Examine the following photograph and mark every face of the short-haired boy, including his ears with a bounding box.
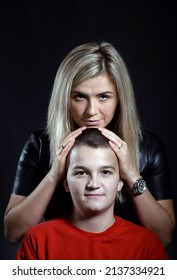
[65,145,122,218]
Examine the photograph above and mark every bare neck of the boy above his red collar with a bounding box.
[70,209,115,233]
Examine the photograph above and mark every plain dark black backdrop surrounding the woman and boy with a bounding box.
[0,0,177,259]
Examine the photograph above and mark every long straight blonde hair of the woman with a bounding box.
[47,42,142,169]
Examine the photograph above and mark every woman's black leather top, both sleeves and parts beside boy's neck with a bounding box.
[13,129,173,222]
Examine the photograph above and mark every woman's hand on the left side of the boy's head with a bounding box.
[49,127,86,183]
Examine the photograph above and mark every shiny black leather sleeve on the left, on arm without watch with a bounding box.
[12,130,49,196]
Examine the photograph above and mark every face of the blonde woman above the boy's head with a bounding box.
[71,73,118,127]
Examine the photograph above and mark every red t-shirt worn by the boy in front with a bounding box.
[16,217,168,260]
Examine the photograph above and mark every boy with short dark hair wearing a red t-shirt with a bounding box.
[17,128,167,260]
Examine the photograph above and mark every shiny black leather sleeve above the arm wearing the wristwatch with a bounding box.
[140,129,173,200]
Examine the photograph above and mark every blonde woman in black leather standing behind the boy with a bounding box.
[4,42,175,245]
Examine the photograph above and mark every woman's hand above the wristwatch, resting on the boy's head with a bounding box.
[98,127,141,187]
